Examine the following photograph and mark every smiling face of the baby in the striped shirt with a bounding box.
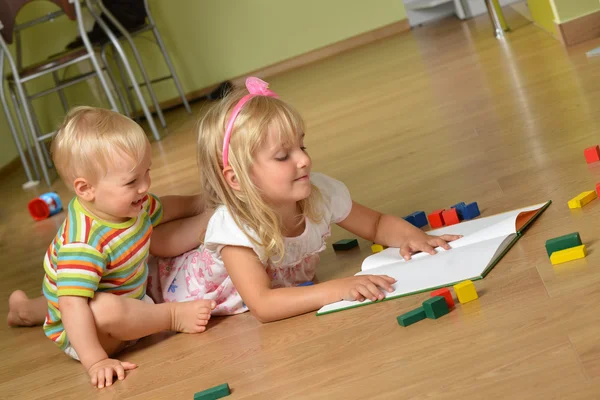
[86,144,152,222]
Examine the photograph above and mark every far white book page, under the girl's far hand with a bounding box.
[361,203,546,271]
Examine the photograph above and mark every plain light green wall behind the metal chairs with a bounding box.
[0,0,406,170]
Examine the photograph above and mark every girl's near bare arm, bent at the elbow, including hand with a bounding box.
[221,246,395,322]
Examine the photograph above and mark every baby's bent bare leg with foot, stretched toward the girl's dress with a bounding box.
[90,293,216,342]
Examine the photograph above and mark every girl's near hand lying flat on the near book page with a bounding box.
[331,275,396,301]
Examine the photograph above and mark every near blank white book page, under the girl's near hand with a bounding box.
[317,233,516,315]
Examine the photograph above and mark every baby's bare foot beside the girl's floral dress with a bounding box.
[169,300,217,333]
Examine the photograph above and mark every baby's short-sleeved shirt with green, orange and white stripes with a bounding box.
[43,195,162,350]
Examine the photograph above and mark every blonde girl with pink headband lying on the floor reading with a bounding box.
[149,78,458,322]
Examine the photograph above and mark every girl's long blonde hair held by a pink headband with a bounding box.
[198,86,322,260]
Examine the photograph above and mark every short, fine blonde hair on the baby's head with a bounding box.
[51,107,149,185]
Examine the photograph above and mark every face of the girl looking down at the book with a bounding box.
[252,129,312,206]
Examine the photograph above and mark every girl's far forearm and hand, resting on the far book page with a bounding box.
[338,201,461,260]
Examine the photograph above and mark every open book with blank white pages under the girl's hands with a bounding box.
[317,201,551,315]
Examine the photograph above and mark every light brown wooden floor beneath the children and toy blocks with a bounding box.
[0,9,600,400]
